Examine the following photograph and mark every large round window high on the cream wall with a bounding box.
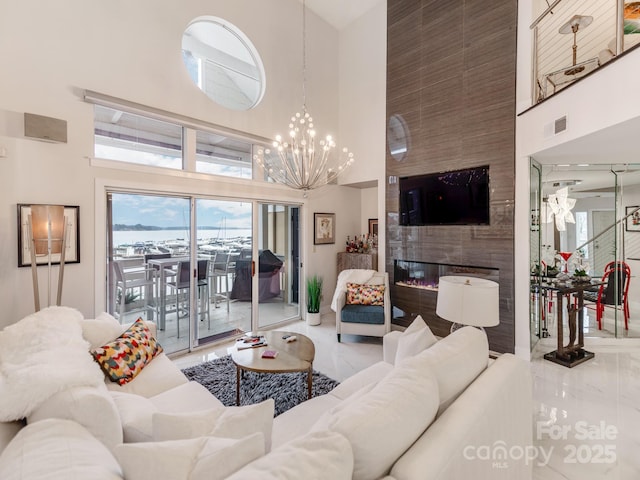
[182,17,265,110]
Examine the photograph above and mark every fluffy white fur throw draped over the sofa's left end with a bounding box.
[0,307,104,421]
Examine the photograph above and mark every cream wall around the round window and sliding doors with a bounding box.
[0,0,378,328]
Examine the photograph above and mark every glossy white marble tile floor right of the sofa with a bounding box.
[531,337,640,480]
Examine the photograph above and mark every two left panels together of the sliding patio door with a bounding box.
[107,192,253,353]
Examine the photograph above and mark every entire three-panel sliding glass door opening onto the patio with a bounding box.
[106,191,300,353]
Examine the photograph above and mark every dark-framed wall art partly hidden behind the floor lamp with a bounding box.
[18,203,80,267]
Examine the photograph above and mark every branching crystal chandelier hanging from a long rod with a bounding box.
[253,0,354,196]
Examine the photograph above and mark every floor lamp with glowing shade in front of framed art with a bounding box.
[28,205,67,312]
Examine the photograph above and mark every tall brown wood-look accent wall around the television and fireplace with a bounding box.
[386,0,517,352]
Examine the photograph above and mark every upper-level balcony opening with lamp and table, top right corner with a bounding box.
[531,0,640,103]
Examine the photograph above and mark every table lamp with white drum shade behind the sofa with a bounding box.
[436,276,500,332]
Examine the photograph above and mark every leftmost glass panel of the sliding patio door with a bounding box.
[107,192,191,352]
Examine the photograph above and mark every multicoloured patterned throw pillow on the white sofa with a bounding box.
[91,318,162,385]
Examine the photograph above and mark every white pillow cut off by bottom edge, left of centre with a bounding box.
[114,433,264,480]
